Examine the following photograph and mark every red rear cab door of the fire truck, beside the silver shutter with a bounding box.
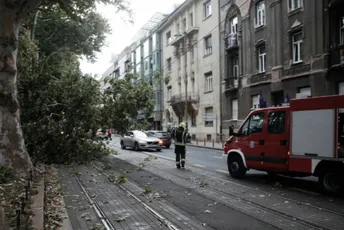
[264,110,289,171]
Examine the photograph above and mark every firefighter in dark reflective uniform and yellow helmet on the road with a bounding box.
[174,122,188,168]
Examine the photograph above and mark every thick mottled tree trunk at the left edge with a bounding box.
[0,4,32,174]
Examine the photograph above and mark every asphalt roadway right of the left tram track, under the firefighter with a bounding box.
[103,141,344,230]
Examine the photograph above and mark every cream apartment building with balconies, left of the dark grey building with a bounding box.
[159,0,221,140]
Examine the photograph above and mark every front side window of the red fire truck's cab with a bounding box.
[239,113,264,136]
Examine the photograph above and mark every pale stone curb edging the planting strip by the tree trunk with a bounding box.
[31,175,44,229]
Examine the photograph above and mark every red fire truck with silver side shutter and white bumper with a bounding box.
[223,95,344,195]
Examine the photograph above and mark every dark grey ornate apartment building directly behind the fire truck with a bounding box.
[221,0,344,137]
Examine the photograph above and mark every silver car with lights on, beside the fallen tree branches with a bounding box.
[120,130,163,151]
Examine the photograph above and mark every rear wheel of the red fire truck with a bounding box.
[319,172,342,196]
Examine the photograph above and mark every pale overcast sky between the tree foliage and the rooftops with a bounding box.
[80,0,184,75]
